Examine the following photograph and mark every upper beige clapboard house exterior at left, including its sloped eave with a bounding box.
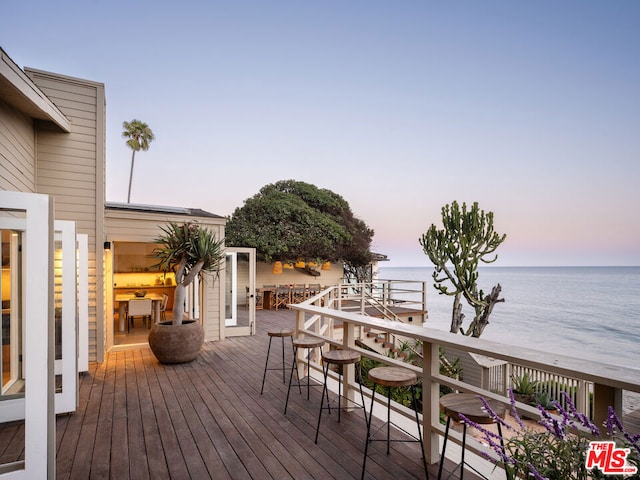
[0,55,105,361]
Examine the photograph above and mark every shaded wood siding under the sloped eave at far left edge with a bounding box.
[0,100,36,192]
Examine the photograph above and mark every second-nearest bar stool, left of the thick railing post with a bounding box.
[362,367,429,480]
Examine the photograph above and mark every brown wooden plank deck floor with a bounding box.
[0,310,477,480]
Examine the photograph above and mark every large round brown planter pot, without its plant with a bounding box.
[149,320,204,363]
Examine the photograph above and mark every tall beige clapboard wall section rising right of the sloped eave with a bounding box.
[25,69,106,362]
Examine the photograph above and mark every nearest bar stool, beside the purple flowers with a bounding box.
[438,393,509,480]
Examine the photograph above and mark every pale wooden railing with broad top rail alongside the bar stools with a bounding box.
[290,286,640,463]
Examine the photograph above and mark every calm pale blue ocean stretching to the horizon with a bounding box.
[379,267,640,369]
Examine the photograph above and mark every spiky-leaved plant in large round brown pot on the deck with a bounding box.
[149,222,224,363]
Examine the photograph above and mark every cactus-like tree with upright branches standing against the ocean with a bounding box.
[420,201,506,337]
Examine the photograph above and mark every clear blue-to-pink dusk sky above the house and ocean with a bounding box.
[0,0,640,266]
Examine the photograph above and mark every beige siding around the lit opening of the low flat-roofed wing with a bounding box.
[105,208,226,341]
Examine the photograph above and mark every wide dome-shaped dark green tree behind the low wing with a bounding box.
[225,180,373,274]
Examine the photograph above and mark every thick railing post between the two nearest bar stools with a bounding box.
[422,341,440,463]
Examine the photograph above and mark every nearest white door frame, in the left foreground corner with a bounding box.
[0,191,56,480]
